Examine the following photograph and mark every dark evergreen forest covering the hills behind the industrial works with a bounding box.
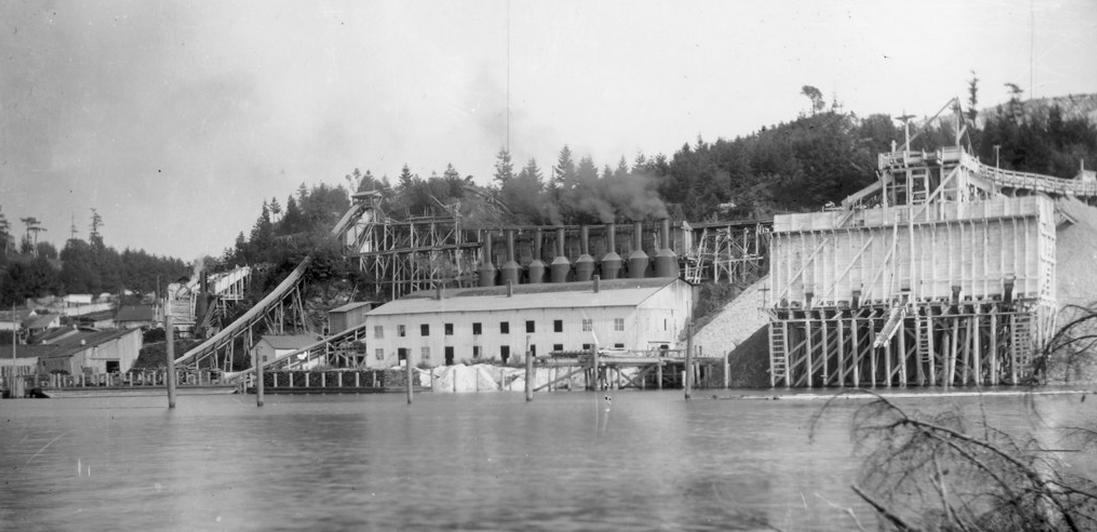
[0,81,1097,302]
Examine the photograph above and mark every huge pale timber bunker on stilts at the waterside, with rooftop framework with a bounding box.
[766,101,1097,387]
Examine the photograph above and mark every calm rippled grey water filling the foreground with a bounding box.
[0,392,1097,531]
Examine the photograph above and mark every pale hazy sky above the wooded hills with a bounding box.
[0,0,1097,261]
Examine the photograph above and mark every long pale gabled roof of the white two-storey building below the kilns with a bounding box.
[367,278,683,316]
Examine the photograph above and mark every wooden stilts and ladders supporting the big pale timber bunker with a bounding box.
[769,302,1037,388]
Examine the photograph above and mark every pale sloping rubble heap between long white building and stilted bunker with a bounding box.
[680,276,772,356]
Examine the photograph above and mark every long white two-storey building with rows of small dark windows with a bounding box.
[365,278,693,367]
